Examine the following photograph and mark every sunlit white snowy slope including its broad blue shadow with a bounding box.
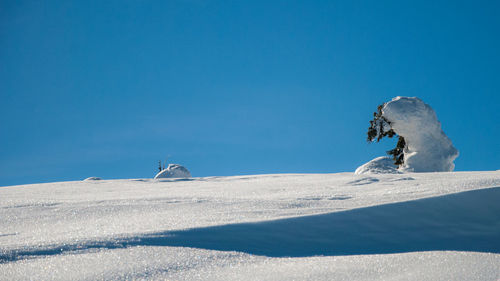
[0,171,500,280]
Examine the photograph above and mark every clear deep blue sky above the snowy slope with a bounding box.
[0,0,500,185]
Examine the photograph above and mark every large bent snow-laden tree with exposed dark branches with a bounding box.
[367,97,458,172]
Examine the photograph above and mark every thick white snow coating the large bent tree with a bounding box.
[382,97,458,172]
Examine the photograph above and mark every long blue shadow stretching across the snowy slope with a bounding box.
[0,187,500,262]
